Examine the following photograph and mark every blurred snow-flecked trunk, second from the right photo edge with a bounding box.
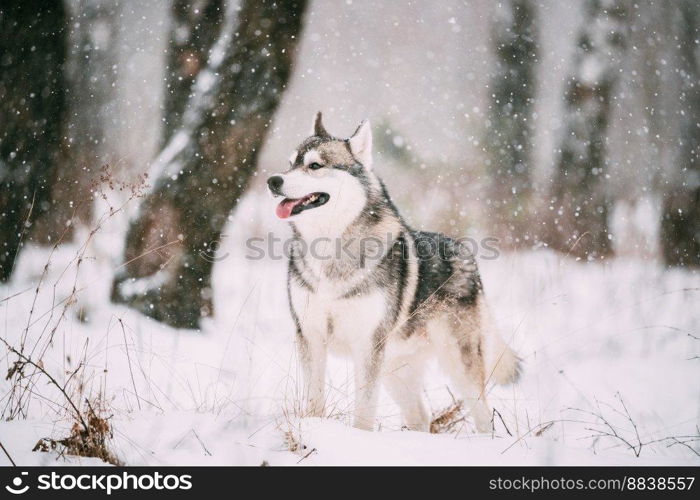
[546,0,630,260]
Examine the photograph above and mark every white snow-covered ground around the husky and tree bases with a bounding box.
[0,196,700,465]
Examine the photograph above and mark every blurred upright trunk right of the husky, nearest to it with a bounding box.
[487,0,537,246]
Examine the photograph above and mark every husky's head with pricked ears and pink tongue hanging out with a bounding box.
[267,112,377,229]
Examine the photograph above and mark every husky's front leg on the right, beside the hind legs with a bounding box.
[353,332,385,431]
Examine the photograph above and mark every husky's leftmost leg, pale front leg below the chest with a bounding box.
[297,333,327,417]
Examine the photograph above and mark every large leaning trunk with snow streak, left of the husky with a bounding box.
[112,0,306,328]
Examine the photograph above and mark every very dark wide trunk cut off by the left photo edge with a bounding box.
[0,0,67,281]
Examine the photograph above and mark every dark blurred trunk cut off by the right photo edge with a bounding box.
[661,0,700,267]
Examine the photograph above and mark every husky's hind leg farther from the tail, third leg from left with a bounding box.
[383,356,430,432]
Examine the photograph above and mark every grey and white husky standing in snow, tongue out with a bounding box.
[267,112,520,432]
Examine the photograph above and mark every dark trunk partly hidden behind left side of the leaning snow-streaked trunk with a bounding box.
[163,0,225,144]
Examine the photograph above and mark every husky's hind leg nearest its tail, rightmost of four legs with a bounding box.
[428,308,491,432]
